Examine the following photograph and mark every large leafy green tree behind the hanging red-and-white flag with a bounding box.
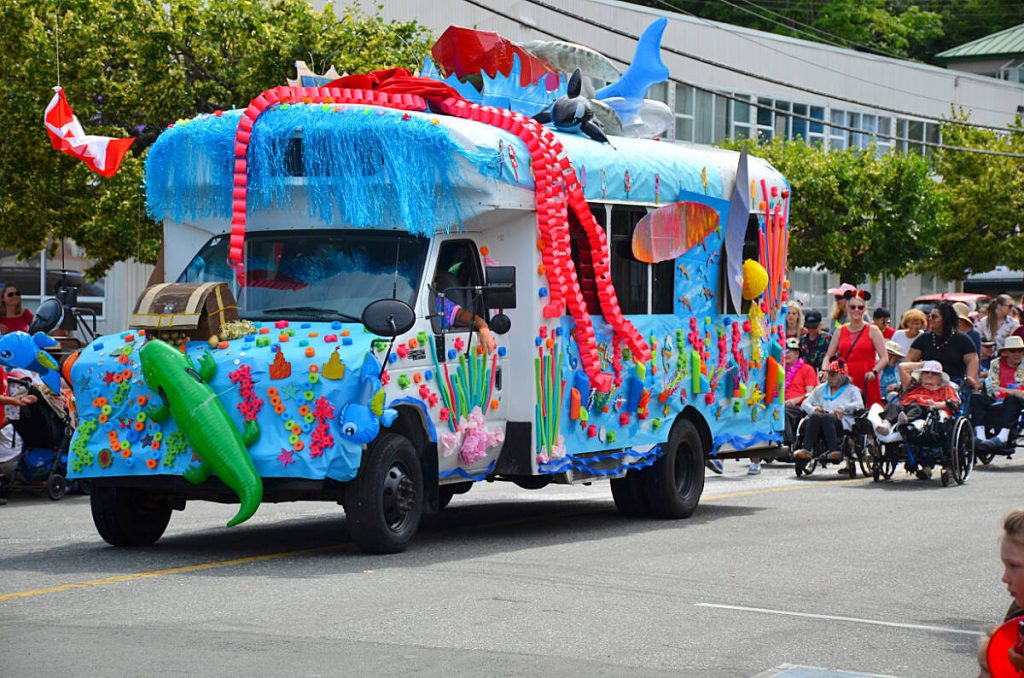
[0,0,431,277]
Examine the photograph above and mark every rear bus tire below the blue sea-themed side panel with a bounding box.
[641,419,705,518]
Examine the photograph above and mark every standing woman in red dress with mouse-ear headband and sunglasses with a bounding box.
[821,290,889,408]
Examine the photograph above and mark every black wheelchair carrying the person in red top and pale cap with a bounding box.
[867,391,975,486]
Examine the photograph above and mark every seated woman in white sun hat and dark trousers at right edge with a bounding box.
[971,335,1024,447]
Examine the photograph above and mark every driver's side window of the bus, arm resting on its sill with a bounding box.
[430,240,486,333]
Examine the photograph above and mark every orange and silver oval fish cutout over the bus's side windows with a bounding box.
[633,202,719,263]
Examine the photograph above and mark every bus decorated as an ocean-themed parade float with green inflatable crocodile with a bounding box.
[61,20,788,552]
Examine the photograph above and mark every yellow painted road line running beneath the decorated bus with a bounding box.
[0,478,867,602]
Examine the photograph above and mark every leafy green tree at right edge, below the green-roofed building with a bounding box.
[928,113,1024,280]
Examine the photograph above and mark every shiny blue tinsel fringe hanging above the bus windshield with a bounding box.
[146,105,483,236]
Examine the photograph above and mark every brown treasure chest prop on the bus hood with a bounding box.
[130,283,239,344]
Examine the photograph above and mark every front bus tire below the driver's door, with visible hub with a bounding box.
[345,433,421,553]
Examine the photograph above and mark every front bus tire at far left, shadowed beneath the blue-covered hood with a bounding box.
[89,485,171,546]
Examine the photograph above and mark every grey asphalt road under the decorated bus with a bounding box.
[0,460,1024,677]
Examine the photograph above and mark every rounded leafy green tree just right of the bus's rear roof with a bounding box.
[730,139,945,282]
